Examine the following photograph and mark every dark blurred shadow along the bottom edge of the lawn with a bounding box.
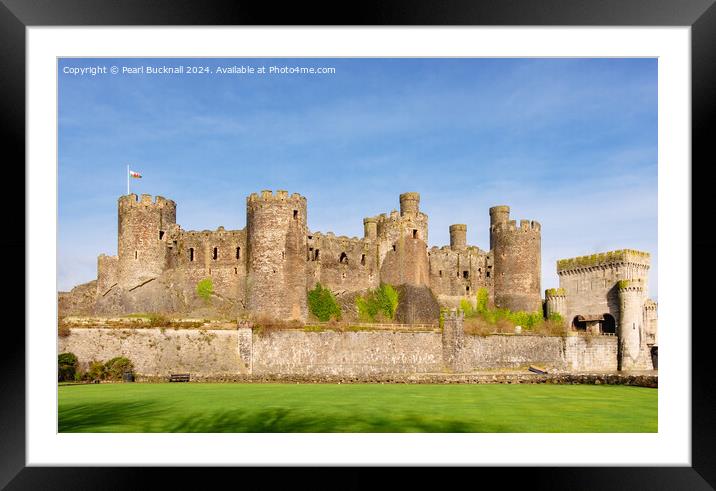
[59,401,498,433]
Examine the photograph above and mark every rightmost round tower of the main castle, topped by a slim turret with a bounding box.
[490,206,542,312]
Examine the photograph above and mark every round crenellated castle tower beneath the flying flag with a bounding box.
[117,194,176,288]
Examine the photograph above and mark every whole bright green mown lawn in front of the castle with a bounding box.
[58,383,657,433]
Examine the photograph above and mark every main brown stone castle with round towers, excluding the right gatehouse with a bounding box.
[81,191,542,320]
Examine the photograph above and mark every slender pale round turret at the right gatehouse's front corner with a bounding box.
[617,280,651,370]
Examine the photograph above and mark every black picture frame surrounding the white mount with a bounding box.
[0,0,716,490]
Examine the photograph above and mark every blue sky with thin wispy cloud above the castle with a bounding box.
[58,58,658,298]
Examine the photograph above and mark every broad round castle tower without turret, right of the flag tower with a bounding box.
[246,191,307,320]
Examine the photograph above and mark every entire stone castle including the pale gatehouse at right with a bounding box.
[60,191,656,369]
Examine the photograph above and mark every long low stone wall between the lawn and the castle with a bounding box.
[58,328,617,378]
